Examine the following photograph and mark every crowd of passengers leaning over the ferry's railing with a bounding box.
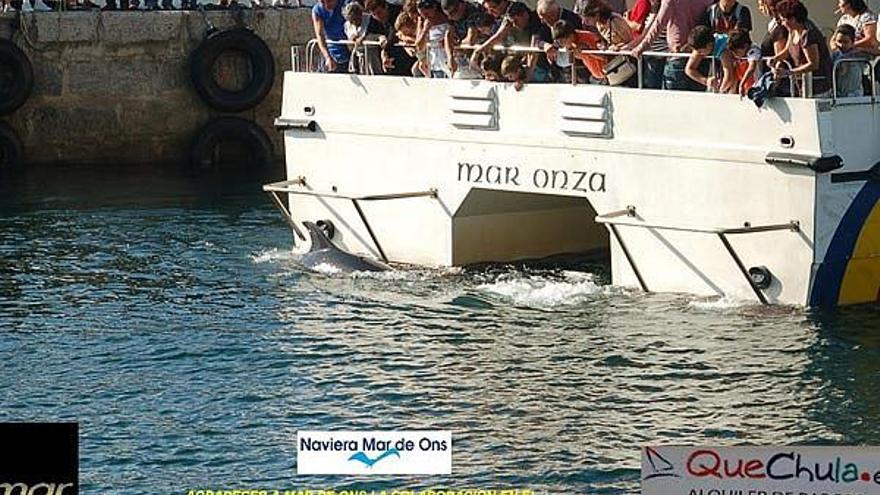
[312,0,880,96]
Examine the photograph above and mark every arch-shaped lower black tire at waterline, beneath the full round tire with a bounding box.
[190,117,274,171]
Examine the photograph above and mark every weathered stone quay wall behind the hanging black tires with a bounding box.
[0,9,312,164]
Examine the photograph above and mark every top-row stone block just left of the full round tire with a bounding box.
[101,11,183,45]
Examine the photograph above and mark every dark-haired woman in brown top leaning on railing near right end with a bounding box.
[770,0,833,96]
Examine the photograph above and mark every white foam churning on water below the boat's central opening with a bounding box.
[477,271,604,308]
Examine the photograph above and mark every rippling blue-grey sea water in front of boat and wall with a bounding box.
[0,167,880,494]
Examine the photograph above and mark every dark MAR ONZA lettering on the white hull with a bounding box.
[458,162,605,193]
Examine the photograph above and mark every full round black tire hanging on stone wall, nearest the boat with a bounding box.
[190,28,275,112]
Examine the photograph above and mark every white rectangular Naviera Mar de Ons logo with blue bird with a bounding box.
[296,430,452,474]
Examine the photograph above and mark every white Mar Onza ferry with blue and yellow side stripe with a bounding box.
[265,43,880,306]
